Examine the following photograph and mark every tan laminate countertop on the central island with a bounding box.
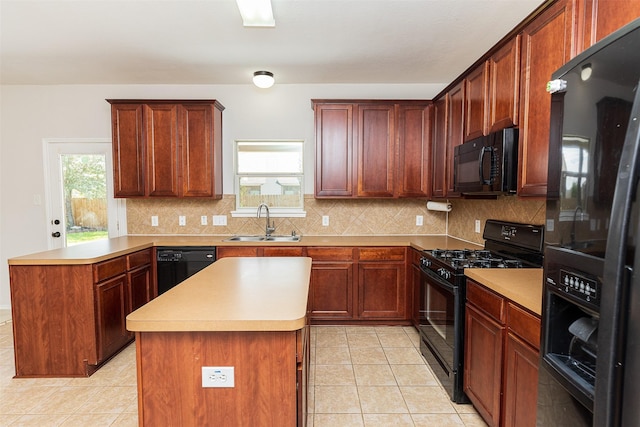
[127,257,311,332]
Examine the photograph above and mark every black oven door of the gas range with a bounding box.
[419,267,467,403]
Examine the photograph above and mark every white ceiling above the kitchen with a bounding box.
[0,0,543,85]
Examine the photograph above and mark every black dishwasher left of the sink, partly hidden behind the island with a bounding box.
[156,246,216,295]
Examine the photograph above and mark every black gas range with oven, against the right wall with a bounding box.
[419,220,544,403]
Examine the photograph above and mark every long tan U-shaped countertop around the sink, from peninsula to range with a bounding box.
[9,235,482,265]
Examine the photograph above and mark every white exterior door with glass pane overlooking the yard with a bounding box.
[44,139,127,249]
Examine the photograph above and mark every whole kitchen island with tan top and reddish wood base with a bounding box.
[127,257,311,426]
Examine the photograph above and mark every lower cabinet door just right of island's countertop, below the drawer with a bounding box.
[309,262,354,320]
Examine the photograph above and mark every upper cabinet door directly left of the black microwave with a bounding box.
[445,81,466,197]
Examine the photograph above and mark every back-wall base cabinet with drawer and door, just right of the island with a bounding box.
[307,247,355,320]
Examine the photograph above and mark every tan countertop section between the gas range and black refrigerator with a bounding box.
[464,268,543,316]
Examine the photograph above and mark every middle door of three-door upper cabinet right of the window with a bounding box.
[357,103,396,197]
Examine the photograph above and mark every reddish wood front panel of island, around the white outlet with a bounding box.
[136,331,297,427]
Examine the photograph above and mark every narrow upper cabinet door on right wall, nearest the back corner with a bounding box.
[431,95,448,197]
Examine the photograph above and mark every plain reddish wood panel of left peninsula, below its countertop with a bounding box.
[9,265,96,377]
